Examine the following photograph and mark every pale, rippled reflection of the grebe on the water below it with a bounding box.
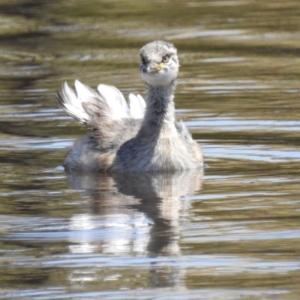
[67,169,203,286]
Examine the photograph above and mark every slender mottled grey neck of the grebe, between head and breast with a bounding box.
[140,80,176,134]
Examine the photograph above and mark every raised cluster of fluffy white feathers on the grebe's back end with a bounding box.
[58,80,146,123]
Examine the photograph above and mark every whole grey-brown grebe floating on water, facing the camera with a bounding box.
[57,41,203,172]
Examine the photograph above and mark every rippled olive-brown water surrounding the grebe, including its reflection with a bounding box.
[0,0,300,300]
